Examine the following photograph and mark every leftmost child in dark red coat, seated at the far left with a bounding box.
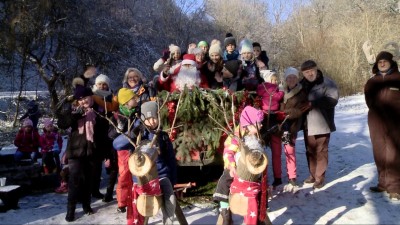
[14,119,40,162]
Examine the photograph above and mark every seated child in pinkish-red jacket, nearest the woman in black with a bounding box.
[40,118,63,174]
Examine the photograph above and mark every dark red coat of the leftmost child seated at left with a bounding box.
[14,128,40,152]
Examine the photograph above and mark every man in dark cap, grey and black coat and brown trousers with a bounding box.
[300,60,339,188]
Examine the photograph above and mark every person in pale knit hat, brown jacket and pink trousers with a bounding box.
[281,67,308,186]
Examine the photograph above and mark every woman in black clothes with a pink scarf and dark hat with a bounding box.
[60,85,107,222]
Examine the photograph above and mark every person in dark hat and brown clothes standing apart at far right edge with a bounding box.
[364,51,400,200]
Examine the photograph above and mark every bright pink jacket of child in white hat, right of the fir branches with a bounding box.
[257,82,285,113]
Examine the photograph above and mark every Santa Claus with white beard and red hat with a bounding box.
[159,54,208,92]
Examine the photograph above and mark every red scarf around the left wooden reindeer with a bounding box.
[126,178,162,225]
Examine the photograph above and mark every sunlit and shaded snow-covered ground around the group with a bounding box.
[0,95,400,224]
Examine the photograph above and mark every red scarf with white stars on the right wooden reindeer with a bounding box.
[230,176,265,225]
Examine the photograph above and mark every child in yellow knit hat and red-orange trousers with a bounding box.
[109,88,138,213]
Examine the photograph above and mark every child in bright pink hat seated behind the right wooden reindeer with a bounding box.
[213,106,264,224]
